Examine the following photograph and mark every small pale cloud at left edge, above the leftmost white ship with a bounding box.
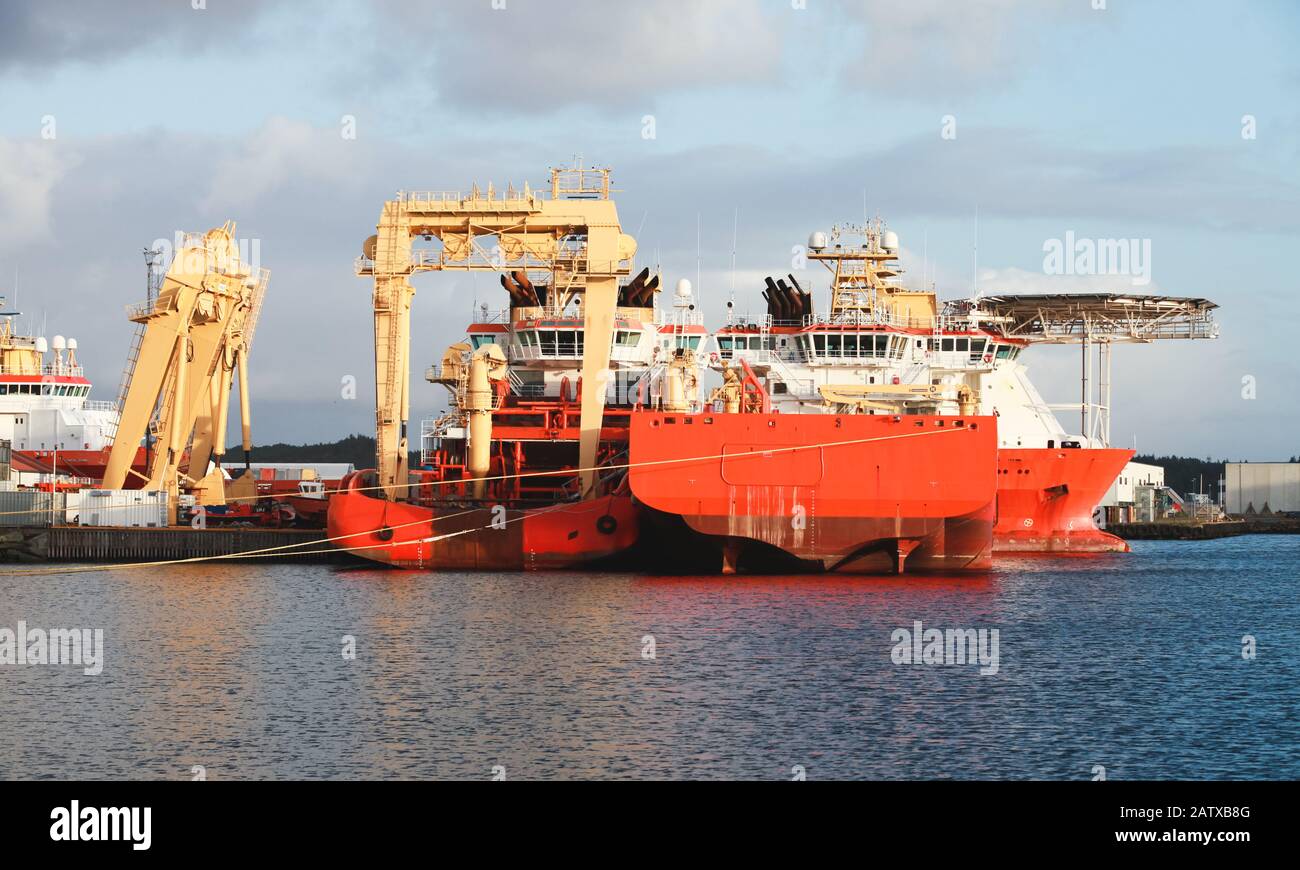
[0,138,81,247]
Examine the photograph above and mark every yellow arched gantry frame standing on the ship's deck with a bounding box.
[356,169,636,501]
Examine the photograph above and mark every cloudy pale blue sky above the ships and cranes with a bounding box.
[0,0,1300,459]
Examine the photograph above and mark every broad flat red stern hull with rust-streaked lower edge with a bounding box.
[629,414,997,573]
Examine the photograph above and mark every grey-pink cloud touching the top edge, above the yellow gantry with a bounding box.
[376,0,783,114]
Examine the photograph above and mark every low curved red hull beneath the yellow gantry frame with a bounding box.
[328,475,638,571]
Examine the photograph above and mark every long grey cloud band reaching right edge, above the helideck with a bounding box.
[619,127,1300,239]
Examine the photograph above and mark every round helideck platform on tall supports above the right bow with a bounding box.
[944,293,1218,446]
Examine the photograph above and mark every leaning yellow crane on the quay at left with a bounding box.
[104,221,269,521]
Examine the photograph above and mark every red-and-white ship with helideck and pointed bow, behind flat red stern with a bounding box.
[710,221,1216,553]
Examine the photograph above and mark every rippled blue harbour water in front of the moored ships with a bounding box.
[0,537,1300,779]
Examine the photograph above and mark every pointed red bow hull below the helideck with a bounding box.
[993,447,1134,553]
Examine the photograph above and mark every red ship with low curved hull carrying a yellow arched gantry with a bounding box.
[328,169,670,570]
